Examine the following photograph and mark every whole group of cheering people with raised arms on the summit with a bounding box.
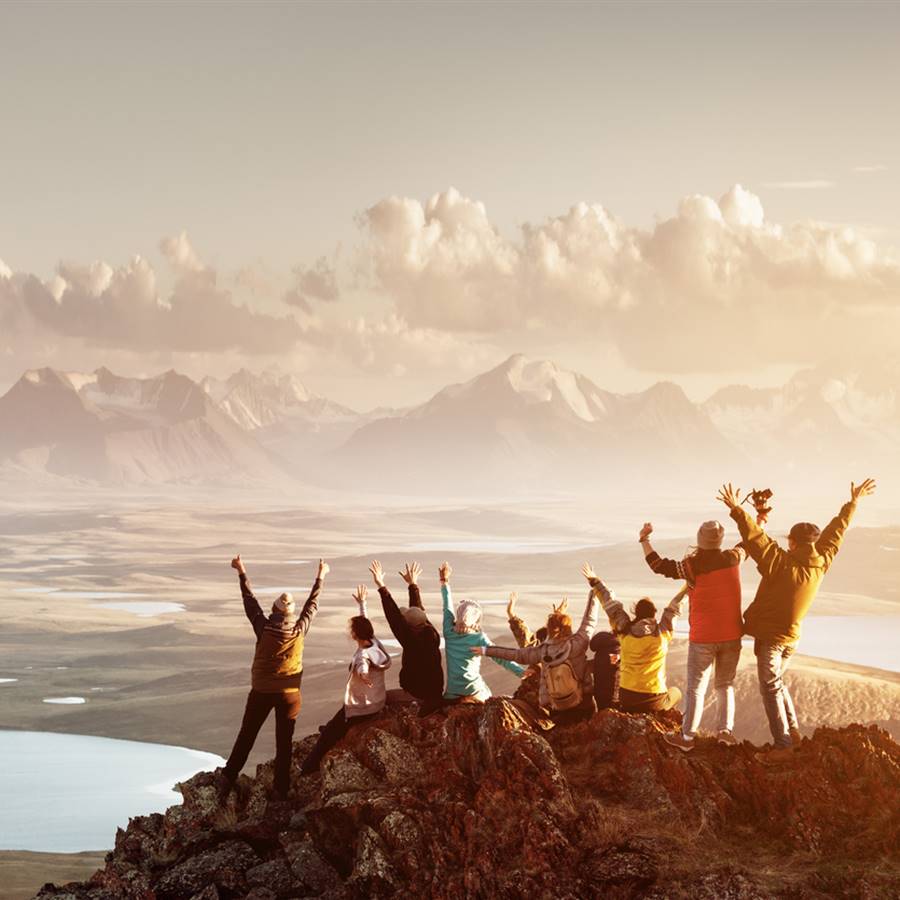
[220,479,875,799]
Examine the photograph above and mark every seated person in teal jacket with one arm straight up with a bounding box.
[438,562,526,703]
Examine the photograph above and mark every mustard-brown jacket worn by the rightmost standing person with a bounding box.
[731,500,856,645]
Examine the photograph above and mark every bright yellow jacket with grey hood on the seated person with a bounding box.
[591,579,685,694]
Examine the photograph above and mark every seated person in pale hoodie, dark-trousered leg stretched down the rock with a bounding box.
[300,584,391,775]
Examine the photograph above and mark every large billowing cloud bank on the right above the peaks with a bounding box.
[360,185,900,372]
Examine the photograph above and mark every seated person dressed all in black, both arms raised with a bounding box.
[369,560,444,717]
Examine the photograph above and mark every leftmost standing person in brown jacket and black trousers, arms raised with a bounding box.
[219,554,328,801]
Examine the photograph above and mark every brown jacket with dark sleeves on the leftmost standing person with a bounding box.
[240,573,322,694]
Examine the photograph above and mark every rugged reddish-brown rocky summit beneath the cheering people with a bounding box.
[38,698,900,900]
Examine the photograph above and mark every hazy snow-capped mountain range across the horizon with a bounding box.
[0,354,900,492]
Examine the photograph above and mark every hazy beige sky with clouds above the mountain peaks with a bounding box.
[0,2,900,409]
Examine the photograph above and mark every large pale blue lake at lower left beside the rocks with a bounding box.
[0,730,224,853]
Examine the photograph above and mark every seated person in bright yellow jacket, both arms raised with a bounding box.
[581,563,687,712]
